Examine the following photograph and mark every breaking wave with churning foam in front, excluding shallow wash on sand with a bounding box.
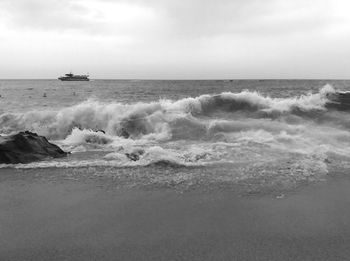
[0,85,350,165]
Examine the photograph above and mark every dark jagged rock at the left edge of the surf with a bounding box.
[0,131,67,164]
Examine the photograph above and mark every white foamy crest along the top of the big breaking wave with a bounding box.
[0,85,334,140]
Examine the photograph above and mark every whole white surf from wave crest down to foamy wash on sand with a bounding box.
[0,85,350,191]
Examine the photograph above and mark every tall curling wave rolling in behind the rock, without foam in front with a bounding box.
[0,85,350,142]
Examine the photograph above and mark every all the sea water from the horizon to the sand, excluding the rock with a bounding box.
[0,80,350,191]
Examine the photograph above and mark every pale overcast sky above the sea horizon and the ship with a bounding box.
[0,0,350,79]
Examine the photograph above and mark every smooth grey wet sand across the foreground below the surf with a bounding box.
[0,169,350,261]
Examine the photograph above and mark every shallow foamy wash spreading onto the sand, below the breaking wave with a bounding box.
[0,143,330,192]
